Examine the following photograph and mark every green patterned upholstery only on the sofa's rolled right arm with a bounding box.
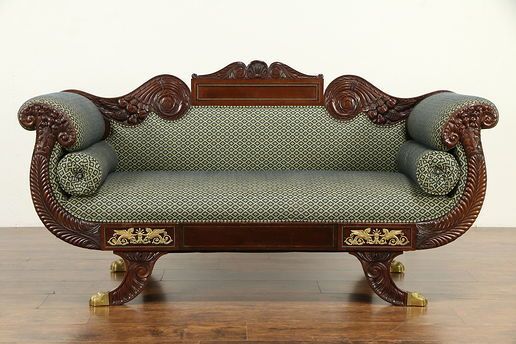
[407,92,496,150]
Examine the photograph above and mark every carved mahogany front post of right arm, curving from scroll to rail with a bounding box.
[417,104,498,249]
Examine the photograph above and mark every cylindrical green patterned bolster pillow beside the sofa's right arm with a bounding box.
[397,141,460,195]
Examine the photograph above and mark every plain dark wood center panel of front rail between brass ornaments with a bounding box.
[181,224,336,251]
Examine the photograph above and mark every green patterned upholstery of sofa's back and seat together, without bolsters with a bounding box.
[33,106,472,223]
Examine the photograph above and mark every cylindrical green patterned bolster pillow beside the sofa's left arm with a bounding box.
[57,141,118,196]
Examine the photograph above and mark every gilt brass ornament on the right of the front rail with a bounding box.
[344,228,409,246]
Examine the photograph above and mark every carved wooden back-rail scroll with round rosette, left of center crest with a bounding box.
[66,75,190,125]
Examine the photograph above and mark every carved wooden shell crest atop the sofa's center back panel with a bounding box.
[192,60,322,79]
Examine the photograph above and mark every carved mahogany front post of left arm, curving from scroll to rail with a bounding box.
[18,103,100,249]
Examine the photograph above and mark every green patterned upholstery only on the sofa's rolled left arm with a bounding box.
[19,92,105,151]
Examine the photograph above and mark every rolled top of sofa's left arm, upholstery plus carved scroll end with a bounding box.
[18,92,106,151]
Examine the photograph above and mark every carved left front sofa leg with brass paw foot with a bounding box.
[90,252,165,307]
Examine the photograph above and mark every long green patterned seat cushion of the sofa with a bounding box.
[62,171,456,222]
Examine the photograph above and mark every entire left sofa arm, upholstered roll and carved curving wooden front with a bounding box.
[18,92,106,249]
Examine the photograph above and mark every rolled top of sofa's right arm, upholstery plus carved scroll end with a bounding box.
[407,92,498,151]
